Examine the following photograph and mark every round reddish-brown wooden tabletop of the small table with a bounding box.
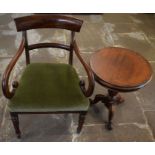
[90,47,152,90]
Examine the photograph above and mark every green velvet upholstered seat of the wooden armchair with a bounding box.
[9,63,89,112]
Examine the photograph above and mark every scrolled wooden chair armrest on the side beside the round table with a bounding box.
[73,40,95,97]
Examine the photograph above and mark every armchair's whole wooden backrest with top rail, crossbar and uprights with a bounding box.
[15,15,83,65]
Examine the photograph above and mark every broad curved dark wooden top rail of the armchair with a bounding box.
[14,14,83,32]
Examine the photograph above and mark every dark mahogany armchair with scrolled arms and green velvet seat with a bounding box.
[2,15,94,138]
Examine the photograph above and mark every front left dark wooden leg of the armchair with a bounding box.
[10,112,21,138]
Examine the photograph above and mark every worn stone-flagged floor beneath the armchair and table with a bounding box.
[0,14,155,142]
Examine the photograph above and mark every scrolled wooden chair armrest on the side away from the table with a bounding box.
[2,38,25,99]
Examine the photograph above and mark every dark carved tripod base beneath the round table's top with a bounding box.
[91,90,124,130]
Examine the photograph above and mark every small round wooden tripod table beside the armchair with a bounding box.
[90,47,152,130]
